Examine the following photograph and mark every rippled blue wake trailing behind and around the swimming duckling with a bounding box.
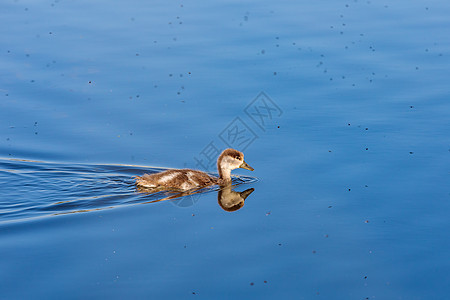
[0,159,256,222]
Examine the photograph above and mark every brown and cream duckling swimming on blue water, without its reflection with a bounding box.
[136,148,254,191]
